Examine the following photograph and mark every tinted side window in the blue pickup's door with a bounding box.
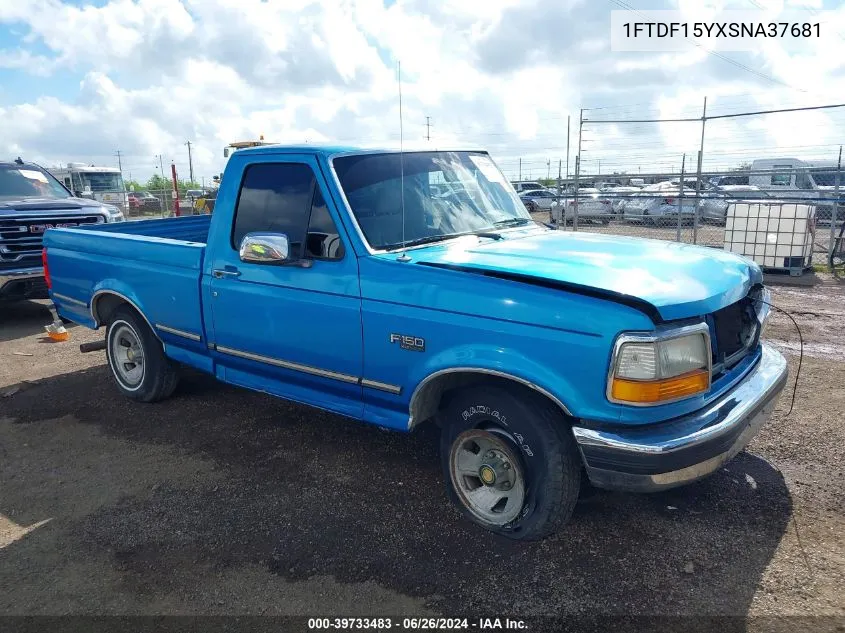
[232,163,315,257]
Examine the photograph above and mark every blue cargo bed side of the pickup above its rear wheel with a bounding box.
[44,215,211,338]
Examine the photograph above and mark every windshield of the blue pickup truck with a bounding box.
[333,152,531,249]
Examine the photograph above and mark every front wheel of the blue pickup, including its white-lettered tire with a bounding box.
[439,383,581,541]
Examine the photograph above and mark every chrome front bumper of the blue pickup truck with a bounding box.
[572,343,788,492]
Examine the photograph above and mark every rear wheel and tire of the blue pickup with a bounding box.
[106,305,179,402]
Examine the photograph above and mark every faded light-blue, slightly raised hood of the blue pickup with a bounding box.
[400,229,762,321]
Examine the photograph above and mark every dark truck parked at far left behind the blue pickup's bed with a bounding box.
[0,158,124,301]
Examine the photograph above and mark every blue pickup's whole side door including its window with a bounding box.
[204,155,363,417]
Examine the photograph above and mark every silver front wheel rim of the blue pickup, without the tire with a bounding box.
[449,429,525,526]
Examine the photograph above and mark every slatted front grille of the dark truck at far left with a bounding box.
[0,213,105,270]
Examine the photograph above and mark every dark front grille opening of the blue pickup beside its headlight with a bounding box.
[707,290,760,375]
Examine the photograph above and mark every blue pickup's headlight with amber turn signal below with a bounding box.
[607,323,711,405]
